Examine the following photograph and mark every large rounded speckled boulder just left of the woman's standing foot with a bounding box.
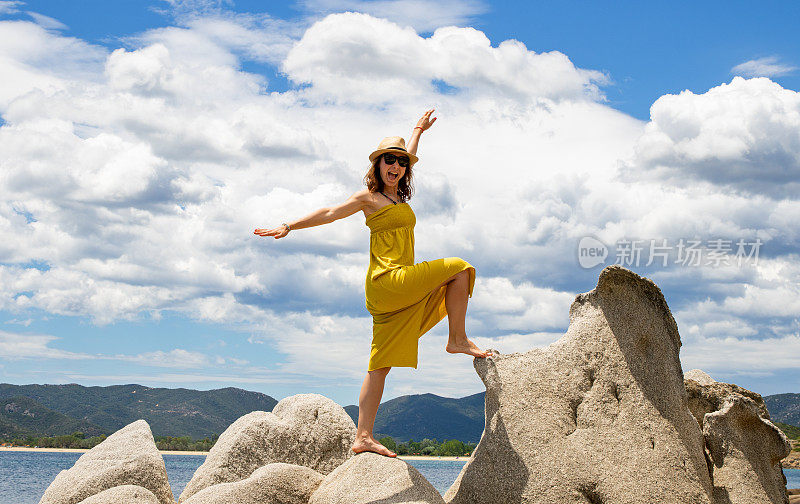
[183,394,356,502]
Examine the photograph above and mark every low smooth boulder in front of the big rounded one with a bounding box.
[185,462,324,504]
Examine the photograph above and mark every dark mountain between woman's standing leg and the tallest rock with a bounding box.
[344,392,485,443]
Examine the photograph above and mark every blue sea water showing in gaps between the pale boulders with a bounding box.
[0,451,800,504]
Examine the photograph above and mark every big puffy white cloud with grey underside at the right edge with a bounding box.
[622,77,800,199]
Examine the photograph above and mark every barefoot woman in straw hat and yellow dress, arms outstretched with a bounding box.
[255,109,491,457]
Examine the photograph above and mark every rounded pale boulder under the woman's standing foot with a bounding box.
[308,452,444,504]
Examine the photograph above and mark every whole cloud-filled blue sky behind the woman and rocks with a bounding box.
[0,0,800,405]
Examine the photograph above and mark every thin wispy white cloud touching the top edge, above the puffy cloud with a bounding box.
[300,0,488,32]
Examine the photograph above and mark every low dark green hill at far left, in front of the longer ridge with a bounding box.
[0,396,111,438]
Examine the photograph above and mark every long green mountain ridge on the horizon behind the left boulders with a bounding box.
[0,383,278,439]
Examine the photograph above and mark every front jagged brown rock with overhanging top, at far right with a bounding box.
[703,394,790,504]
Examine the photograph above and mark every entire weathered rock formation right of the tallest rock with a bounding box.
[684,369,790,504]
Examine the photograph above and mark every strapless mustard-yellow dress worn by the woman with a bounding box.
[364,203,475,371]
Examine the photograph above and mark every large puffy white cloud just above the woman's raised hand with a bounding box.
[283,13,607,104]
